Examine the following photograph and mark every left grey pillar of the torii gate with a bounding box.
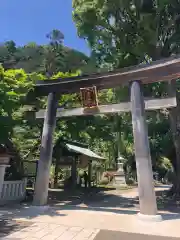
[33,93,58,206]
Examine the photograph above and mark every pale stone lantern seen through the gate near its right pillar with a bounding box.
[114,156,126,187]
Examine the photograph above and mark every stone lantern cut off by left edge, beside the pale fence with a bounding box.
[0,144,11,195]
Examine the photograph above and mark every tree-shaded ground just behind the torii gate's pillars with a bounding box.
[46,187,180,214]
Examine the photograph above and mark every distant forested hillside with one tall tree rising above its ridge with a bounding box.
[0,30,95,74]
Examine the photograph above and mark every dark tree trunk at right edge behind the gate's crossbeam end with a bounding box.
[168,80,180,195]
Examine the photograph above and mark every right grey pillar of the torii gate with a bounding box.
[131,81,158,217]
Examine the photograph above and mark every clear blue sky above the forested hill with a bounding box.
[0,0,89,54]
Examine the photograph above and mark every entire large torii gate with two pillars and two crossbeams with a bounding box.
[29,56,180,219]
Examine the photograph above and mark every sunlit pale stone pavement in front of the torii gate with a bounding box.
[2,186,180,240]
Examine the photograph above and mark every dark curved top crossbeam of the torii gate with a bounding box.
[35,55,180,96]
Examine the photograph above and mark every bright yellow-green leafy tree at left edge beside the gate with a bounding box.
[0,66,35,178]
